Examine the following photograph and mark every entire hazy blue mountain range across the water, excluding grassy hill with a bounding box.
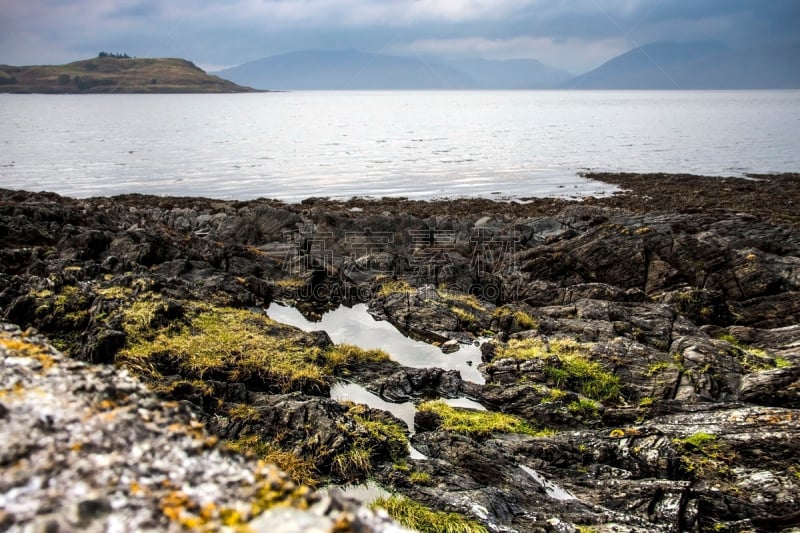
[218,41,800,90]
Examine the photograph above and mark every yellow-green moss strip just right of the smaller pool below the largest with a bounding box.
[418,400,543,437]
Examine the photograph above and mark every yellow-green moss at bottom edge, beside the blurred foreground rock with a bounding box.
[371,496,488,533]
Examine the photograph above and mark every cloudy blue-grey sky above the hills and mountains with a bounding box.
[0,0,800,73]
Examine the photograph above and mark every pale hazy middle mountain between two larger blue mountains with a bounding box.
[447,58,573,89]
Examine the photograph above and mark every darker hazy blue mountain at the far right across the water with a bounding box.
[559,42,800,89]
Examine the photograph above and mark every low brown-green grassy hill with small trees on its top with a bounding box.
[0,57,254,94]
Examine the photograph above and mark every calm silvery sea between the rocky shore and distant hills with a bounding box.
[0,91,800,201]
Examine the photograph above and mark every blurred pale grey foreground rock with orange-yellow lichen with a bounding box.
[0,323,403,533]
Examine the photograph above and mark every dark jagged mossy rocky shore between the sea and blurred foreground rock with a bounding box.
[0,174,800,532]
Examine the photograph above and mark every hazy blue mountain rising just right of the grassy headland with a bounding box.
[217,50,474,90]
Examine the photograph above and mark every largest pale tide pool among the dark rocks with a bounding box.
[266,302,486,384]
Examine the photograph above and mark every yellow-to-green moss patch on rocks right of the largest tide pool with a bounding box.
[498,339,622,401]
